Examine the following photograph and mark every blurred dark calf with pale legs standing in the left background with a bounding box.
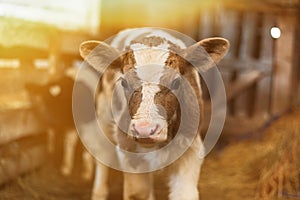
[26,75,94,179]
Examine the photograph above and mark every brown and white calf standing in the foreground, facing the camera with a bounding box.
[80,28,229,200]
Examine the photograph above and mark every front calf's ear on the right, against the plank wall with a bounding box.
[184,37,230,71]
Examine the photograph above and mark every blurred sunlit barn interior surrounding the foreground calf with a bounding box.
[0,0,300,200]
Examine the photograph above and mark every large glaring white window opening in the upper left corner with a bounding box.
[0,0,101,34]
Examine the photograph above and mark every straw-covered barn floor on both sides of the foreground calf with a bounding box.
[0,108,300,200]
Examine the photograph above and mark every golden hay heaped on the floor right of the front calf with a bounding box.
[200,108,300,200]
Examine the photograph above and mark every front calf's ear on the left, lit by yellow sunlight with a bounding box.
[79,40,121,73]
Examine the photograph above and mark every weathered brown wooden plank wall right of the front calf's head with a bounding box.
[198,0,300,133]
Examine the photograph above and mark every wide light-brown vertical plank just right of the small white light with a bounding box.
[271,15,297,115]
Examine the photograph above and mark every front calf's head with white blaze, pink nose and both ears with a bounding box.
[80,36,229,144]
